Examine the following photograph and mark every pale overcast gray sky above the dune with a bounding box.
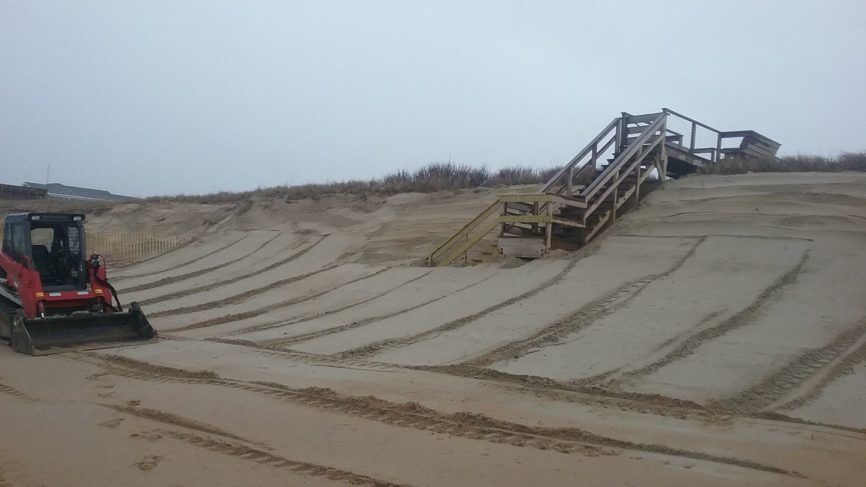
[0,0,866,196]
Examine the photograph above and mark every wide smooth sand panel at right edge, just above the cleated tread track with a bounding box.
[626,243,866,404]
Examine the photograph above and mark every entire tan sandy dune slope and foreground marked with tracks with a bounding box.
[0,174,866,486]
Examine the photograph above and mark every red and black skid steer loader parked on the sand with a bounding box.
[0,213,156,355]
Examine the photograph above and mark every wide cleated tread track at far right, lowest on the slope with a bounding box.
[708,320,866,414]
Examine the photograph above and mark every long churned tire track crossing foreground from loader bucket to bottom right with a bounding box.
[78,353,803,478]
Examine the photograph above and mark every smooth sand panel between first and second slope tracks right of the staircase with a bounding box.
[496,237,808,381]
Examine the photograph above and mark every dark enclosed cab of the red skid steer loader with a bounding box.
[3,213,87,291]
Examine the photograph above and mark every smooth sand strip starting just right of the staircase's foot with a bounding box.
[371,237,700,365]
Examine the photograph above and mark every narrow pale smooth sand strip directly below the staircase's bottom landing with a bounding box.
[291,260,569,354]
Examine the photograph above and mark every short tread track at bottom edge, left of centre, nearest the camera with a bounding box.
[158,430,401,487]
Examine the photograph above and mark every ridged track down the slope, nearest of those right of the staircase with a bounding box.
[464,237,707,367]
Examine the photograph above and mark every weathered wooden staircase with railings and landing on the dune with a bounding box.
[427,108,779,266]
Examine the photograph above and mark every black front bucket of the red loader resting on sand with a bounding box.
[10,303,156,355]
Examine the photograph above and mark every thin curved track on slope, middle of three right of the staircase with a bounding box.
[617,250,810,388]
